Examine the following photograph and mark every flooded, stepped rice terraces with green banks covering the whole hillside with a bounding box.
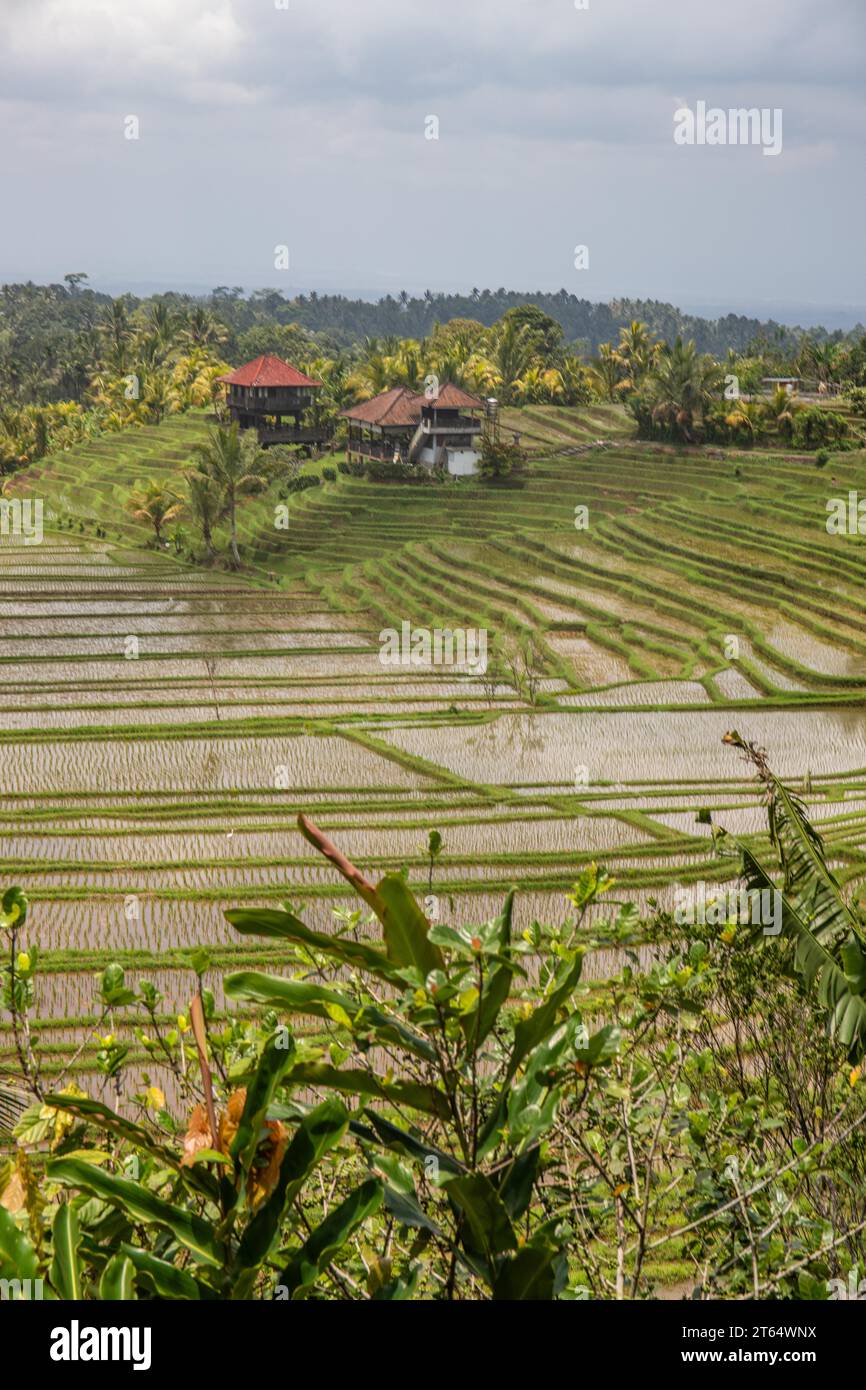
[0,406,866,1056]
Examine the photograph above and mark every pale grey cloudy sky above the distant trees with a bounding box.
[0,0,866,318]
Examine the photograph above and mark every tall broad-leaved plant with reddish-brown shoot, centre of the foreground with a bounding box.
[225,815,616,1300]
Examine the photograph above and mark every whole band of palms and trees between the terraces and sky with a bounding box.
[0,275,866,473]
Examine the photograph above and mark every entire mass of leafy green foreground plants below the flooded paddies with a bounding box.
[0,734,866,1300]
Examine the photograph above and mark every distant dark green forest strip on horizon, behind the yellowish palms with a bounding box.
[0,274,866,403]
